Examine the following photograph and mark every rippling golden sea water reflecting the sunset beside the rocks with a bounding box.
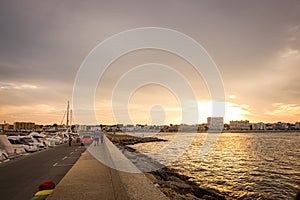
[133,133,300,199]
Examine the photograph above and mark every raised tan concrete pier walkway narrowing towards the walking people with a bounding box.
[47,138,168,200]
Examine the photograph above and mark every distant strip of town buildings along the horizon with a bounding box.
[0,117,300,133]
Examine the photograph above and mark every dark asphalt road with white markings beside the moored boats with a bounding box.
[0,144,86,200]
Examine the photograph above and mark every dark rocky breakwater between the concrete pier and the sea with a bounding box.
[108,135,225,200]
